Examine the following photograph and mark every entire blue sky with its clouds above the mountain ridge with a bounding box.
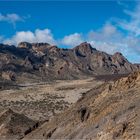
[0,0,140,62]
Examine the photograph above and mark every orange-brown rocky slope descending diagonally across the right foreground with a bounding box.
[24,72,140,140]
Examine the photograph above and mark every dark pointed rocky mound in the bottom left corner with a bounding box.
[0,109,38,139]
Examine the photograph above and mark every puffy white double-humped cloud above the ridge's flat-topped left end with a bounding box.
[3,29,56,45]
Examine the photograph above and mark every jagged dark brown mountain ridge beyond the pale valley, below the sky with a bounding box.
[0,42,139,83]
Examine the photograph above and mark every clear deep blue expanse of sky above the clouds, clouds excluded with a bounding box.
[0,1,125,38]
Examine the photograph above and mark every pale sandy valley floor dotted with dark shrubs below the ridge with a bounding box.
[0,78,102,120]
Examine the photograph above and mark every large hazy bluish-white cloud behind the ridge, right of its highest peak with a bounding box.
[86,23,140,62]
